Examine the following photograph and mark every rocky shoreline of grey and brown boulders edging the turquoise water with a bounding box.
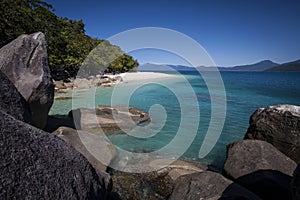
[0,33,300,200]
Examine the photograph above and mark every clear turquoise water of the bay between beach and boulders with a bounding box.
[50,72,300,167]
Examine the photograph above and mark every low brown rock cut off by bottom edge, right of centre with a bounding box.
[169,171,260,200]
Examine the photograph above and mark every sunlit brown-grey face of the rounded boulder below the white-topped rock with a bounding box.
[224,140,296,179]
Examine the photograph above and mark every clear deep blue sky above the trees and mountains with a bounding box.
[46,0,300,66]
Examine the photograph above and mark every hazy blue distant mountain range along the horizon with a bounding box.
[138,60,300,72]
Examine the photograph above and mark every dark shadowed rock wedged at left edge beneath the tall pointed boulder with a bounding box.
[0,71,31,123]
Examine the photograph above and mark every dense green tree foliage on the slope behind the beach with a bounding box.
[0,0,138,79]
